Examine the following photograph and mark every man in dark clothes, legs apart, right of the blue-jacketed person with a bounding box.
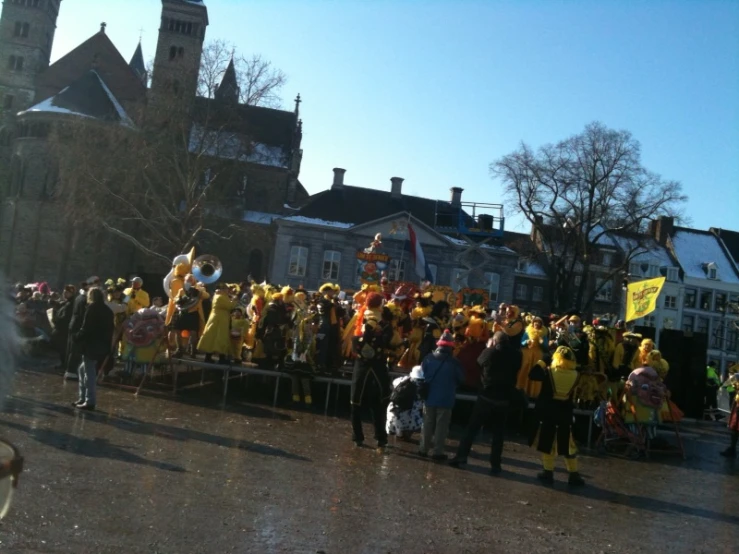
[449,331,522,474]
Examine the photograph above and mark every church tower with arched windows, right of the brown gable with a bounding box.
[151,0,208,104]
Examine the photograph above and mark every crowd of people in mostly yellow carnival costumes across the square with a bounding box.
[15,252,739,476]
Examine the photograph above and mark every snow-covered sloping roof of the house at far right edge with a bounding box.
[672,228,739,284]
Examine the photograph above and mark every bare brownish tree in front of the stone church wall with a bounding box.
[49,100,251,265]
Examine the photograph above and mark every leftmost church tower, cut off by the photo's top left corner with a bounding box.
[0,0,61,118]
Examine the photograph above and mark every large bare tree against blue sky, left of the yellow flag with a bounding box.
[490,122,687,311]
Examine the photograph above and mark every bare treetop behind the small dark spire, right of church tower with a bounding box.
[198,40,287,108]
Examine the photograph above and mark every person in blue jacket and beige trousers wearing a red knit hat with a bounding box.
[418,329,464,460]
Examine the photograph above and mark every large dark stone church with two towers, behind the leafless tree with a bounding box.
[0,0,308,293]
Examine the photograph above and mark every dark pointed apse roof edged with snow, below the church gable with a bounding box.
[18,70,133,126]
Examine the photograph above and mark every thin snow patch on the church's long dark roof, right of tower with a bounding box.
[189,124,287,168]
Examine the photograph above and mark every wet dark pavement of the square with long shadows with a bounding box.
[0,360,739,553]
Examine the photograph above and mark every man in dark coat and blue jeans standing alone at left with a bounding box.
[73,287,115,411]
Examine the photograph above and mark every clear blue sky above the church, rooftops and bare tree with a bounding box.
[52,0,739,231]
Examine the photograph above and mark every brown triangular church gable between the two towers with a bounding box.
[36,31,146,103]
